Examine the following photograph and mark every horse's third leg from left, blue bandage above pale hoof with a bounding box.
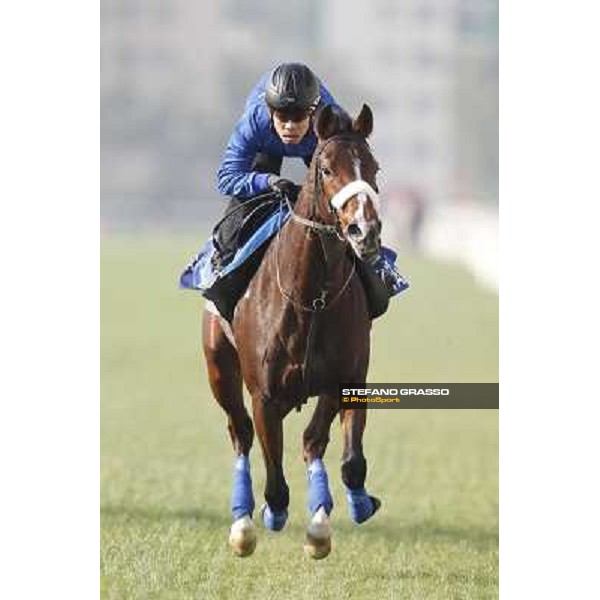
[303,394,339,558]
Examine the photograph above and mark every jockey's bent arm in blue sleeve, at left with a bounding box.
[217,111,269,198]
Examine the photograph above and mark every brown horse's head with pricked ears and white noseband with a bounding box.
[314,104,381,261]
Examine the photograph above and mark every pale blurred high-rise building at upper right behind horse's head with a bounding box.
[324,0,498,201]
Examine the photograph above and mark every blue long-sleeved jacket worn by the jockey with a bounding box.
[217,73,337,198]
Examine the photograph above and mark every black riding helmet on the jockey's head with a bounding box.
[265,63,321,110]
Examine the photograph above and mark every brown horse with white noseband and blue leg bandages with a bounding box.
[203,105,381,558]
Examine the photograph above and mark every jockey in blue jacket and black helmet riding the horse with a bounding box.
[214,63,408,296]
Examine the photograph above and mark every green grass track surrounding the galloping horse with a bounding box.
[101,234,498,599]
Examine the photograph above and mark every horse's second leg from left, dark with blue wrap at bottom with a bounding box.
[252,396,290,531]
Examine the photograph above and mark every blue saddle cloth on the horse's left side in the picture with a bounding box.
[179,202,290,321]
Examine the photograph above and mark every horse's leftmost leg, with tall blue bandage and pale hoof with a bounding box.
[202,311,256,556]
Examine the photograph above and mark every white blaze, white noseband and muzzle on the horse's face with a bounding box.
[331,151,381,261]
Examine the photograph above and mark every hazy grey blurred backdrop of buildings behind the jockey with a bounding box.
[101,0,498,253]
